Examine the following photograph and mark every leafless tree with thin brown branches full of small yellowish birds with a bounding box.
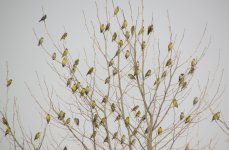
[1,0,225,150]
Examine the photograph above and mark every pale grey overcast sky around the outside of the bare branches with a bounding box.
[0,0,229,150]
